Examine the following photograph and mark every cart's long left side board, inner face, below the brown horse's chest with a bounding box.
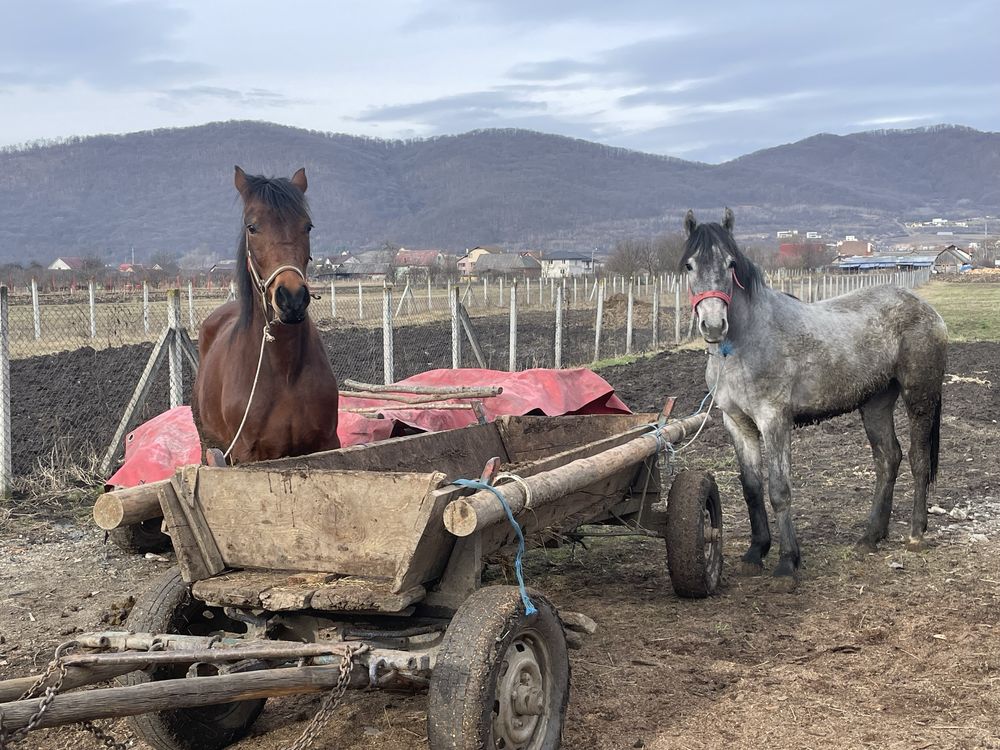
[244,422,509,480]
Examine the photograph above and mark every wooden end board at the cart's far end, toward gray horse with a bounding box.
[497,414,657,474]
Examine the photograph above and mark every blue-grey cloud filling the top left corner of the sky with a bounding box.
[0,0,208,89]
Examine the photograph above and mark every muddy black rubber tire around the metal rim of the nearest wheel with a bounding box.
[427,586,570,750]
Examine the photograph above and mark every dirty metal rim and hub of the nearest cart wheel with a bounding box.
[493,637,547,750]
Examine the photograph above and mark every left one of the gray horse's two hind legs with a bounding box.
[857,383,903,552]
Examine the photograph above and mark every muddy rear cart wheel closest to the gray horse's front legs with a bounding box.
[666,471,722,599]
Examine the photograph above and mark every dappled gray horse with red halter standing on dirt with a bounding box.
[681,208,948,589]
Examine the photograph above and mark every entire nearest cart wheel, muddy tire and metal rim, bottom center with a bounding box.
[427,586,569,750]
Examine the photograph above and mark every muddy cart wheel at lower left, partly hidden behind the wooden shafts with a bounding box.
[125,567,265,750]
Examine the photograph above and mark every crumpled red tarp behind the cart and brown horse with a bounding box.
[108,368,630,494]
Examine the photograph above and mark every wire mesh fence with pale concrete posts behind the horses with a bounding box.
[0,272,928,496]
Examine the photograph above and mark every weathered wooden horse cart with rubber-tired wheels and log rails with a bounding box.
[0,414,722,750]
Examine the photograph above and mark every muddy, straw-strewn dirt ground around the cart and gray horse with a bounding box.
[0,344,1000,750]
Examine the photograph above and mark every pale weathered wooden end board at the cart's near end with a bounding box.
[193,467,443,580]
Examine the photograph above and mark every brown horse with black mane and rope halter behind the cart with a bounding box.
[192,167,340,463]
